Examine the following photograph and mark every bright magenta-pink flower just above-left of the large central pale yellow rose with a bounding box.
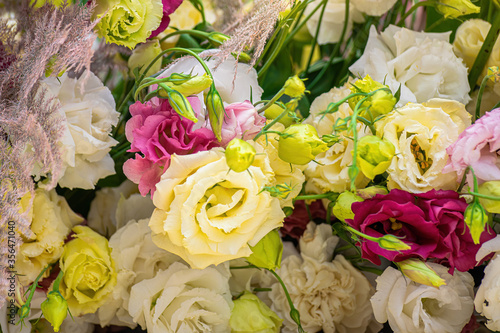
[123,97,218,196]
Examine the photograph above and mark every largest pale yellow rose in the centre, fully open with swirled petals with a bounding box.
[149,149,284,269]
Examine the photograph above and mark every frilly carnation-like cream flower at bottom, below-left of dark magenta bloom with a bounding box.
[269,222,378,333]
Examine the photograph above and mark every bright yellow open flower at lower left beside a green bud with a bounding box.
[59,226,117,316]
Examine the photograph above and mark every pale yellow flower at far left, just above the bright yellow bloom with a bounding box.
[16,189,83,286]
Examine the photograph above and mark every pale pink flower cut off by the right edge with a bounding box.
[443,109,500,185]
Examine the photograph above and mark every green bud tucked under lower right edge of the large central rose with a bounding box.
[247,229,283,270]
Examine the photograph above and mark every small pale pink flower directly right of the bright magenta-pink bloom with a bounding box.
[221,101,266,147]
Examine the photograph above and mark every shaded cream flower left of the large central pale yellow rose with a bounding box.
[87,180,155,237]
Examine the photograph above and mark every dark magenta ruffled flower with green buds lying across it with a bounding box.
[346,189,495,272]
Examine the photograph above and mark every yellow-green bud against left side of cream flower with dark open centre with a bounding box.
[357,135,396,179]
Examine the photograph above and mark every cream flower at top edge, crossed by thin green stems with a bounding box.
[304,0,364,45]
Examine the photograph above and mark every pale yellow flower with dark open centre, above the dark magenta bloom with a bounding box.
[375,98,471,193]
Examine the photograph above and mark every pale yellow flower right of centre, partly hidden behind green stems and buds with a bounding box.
[304,83,371,193]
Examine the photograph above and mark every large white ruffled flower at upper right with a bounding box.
[349,25,470,105]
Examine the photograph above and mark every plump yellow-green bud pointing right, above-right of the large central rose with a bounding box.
[278,124,328,165]
